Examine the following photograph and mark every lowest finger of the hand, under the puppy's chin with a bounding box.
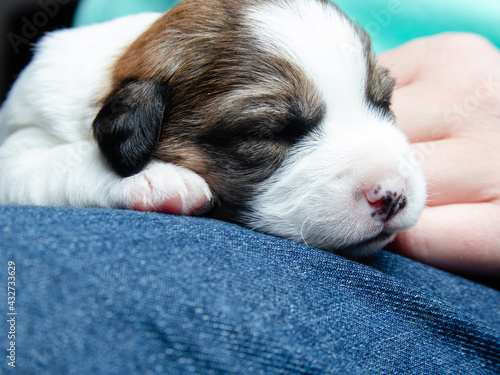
[393,203,500,277]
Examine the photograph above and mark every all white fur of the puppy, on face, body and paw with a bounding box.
[0,0,425,253]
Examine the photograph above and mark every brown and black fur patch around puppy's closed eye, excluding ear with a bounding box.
[106,0,324,219]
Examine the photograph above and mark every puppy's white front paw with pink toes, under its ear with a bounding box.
[120,161,212,215]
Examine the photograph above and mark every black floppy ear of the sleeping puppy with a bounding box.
[93,80,168,177]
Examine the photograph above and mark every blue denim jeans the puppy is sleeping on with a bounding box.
[0,207,500,375]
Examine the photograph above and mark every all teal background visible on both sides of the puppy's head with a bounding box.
[74,0,500,52]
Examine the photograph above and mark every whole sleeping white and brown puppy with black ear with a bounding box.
[0,0,425,256]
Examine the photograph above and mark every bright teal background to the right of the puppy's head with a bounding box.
[335,0,500,52]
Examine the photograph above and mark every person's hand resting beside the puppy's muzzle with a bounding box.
[379,34,500,277]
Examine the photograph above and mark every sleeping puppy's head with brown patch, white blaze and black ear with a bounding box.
[94,0,425,254]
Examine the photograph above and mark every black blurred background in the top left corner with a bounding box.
[0,0,78,103]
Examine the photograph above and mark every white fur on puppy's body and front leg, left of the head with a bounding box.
[0,13,211,214]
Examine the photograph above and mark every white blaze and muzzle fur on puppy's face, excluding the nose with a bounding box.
[247,0,426,255]
